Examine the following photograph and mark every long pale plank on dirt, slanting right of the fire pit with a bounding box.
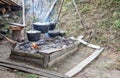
[65,48,104,77]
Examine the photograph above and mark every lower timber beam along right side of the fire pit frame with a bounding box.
[48,47,78,67]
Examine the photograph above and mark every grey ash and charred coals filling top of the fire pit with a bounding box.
[18,37,75,53]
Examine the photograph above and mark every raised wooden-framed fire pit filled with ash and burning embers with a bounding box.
[10,37,78,67]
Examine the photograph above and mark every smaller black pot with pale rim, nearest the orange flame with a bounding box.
[27,30,41,42]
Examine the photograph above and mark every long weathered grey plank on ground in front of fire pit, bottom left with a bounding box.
[0,60,69,78]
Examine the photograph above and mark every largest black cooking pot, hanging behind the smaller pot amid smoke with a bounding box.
[33,22,56,33]
